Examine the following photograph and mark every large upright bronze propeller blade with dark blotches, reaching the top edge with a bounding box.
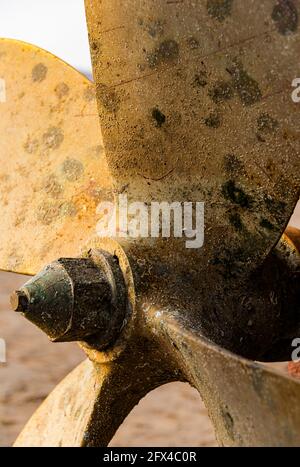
[85,0,300,280]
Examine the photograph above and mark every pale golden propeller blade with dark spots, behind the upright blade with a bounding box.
[0,39,113,274]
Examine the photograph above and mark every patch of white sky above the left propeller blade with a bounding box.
[0,0,92,77]
